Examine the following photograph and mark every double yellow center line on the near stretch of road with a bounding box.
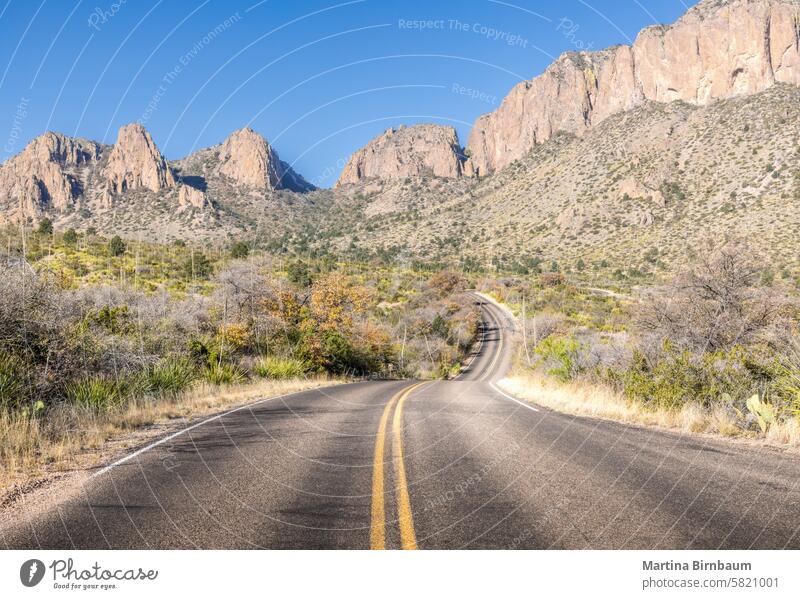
[369,383,426,549]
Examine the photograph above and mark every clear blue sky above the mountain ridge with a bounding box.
[0,0,695,186]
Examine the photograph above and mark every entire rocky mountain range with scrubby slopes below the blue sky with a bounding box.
[0,0,800,276]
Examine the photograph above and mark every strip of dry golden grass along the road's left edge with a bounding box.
[0,377,343,494]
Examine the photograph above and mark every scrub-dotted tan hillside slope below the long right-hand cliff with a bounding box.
[329,84,800,274]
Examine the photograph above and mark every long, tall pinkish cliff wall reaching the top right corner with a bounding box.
[467,0,800,175]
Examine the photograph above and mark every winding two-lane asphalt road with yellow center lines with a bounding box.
[0,302,800,549]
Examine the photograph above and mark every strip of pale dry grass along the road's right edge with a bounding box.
[499,373,800,448]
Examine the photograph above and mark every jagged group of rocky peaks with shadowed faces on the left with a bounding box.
[0,123,313,239]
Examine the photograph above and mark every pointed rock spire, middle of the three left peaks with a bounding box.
[104,123,175,194]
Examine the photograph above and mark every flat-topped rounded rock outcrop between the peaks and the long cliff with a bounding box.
[336,125,464,187]
